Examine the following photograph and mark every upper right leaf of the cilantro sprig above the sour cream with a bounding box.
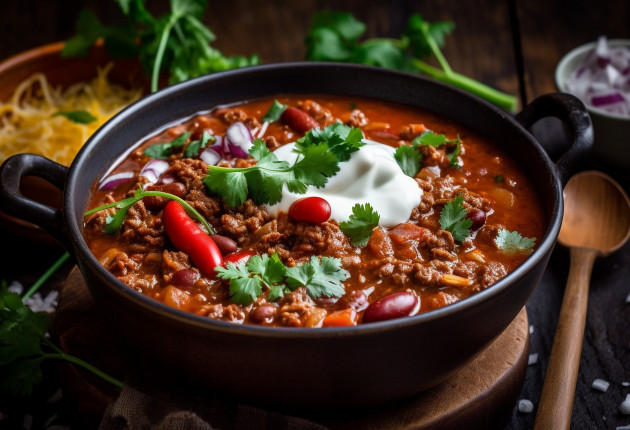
[296,123,365,162]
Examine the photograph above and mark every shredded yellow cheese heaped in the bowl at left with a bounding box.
[0,64,142,166]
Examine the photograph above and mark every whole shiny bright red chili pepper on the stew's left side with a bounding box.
[162,200,223,276]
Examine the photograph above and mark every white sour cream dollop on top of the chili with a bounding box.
[267,140,422,227]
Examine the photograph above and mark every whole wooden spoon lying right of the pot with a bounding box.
[534,171,630,430]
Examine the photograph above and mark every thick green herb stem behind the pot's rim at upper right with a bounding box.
[412,59,518,113]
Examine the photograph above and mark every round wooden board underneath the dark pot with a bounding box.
[54,268,529,430]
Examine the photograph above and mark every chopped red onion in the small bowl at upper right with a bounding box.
[565,36,630,116]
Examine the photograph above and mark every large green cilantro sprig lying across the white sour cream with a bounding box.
[204,124,363,207]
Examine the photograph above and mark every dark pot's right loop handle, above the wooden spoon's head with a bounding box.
[516,93,593,186]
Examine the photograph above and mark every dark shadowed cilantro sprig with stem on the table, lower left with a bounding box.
[0,281,123,396]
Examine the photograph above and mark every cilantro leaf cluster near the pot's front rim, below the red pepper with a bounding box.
[215,254,350,306]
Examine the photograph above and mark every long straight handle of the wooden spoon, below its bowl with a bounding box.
[534,248,597,430]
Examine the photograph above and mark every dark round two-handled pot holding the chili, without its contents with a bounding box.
[0,63,592,408]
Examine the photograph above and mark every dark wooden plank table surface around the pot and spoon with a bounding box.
[0,0,630,429]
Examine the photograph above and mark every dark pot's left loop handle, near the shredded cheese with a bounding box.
[0,154,72,249]
